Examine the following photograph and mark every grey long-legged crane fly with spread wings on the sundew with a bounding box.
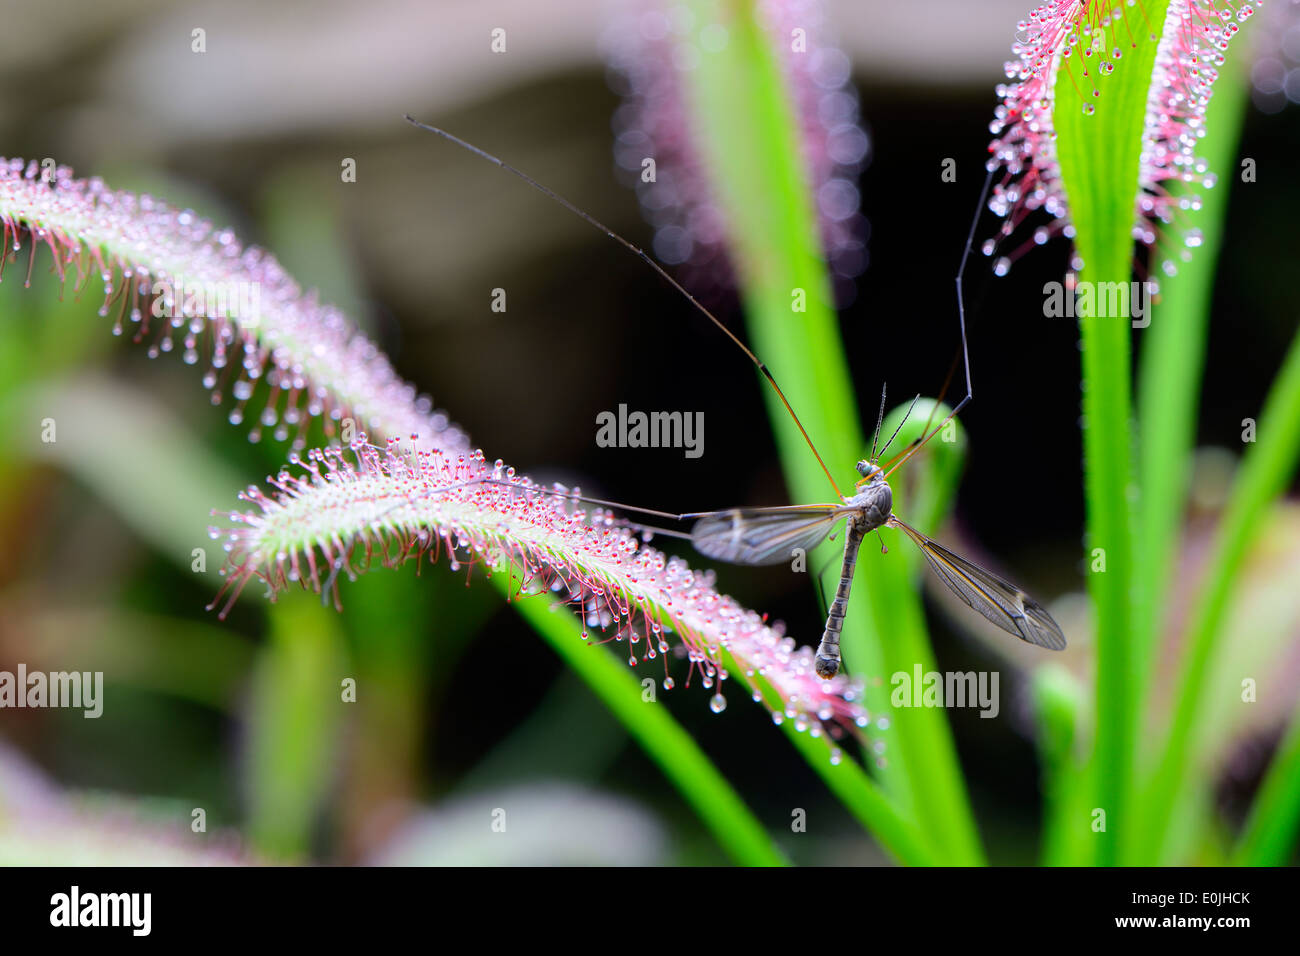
[406,116,1066,680]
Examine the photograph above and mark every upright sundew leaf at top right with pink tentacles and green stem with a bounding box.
[987,0,1255,862]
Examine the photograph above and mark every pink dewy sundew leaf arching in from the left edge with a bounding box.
[0,159,468,451]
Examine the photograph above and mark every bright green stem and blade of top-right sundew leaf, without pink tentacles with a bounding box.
[1053,0,1169,865]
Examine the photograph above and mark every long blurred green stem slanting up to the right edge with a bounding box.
[1145,327,1300,861]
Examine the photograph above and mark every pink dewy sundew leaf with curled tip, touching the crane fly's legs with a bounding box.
[212,440,868,735]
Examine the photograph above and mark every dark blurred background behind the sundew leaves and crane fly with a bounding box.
[0,0,1300,864]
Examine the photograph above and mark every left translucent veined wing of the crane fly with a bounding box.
[684,505,852,564]
